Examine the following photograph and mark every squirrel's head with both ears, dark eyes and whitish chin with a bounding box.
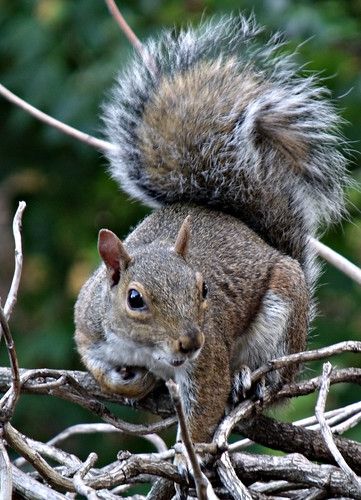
[98,217,208,367]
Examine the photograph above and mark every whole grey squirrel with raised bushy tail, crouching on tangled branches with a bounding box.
[75,16,346,442]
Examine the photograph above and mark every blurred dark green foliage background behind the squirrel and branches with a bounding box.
[0,0,361,480]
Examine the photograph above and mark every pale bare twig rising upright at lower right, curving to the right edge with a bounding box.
[315,362,361,495]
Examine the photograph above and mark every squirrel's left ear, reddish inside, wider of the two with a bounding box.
[98,229,132,286]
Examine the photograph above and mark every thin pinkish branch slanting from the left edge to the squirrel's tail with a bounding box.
[0,84,118,152]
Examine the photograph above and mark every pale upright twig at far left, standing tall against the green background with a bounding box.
[4,201,26,321]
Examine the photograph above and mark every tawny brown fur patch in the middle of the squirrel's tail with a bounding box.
[137,58,263,177]
